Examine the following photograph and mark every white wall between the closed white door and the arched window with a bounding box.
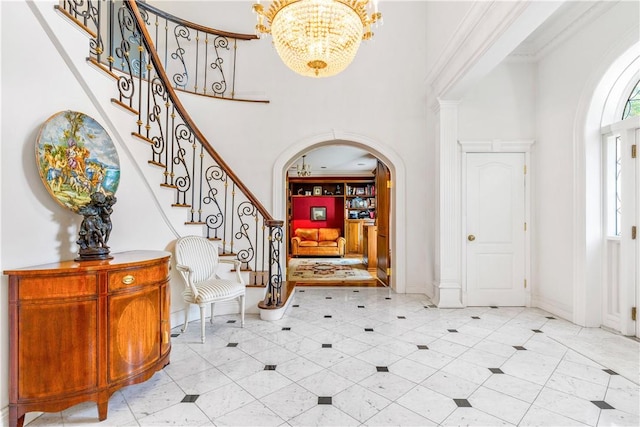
[533,2,640,320]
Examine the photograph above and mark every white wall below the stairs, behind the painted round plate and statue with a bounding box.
[0,2,176,409]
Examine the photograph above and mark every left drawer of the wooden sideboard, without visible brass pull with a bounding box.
[18,274,98,301]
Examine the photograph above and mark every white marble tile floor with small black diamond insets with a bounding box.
[29,288,640,426]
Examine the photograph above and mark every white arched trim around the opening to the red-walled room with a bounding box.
[272,130,408,293]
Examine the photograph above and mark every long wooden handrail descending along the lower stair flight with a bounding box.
[124,0,274,221]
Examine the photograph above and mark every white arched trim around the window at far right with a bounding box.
[571,37,640,327]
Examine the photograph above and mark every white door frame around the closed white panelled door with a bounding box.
[458,140,535,307]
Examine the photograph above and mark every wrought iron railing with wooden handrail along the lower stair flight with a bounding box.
[56,0,283,307]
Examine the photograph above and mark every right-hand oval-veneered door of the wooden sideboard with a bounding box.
[108,286,161,382]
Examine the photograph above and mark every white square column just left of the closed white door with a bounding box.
[435,100,463,308]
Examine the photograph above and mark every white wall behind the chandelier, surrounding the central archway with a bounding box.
[172,2,433,292]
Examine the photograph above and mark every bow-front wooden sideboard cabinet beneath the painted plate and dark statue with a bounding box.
[4,251,171,427]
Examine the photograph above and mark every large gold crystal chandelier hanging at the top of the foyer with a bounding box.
[253,0,382,77]
